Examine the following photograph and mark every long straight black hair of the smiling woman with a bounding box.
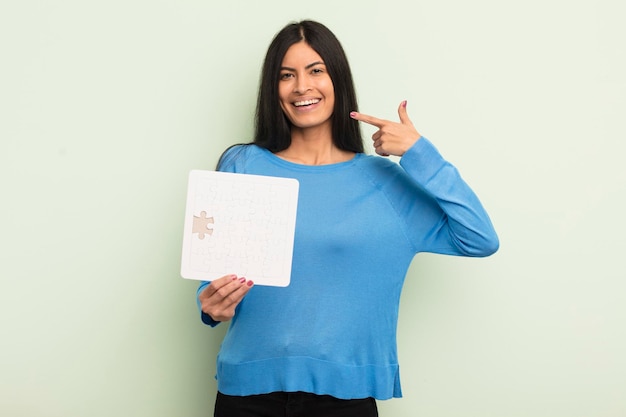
[254,20,364,153]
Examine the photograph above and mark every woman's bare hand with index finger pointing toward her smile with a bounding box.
[350,100,422,156]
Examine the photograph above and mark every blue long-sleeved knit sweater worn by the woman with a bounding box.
[198,138,498,399]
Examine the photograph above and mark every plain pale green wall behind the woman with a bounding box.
[0,0,626,417]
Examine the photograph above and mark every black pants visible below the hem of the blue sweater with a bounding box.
[214,392,378,417]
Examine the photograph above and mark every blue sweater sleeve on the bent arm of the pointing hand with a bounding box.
[400,137,499,257]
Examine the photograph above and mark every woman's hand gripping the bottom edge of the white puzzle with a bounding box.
[198,275,254,321]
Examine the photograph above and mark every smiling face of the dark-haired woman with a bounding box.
[278,41,335,129]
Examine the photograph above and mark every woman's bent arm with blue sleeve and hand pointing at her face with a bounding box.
[350,101,499,256]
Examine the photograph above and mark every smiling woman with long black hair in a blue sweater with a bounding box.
[198,21,498,417]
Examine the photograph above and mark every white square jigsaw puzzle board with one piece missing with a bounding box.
[181,170,299,287]
